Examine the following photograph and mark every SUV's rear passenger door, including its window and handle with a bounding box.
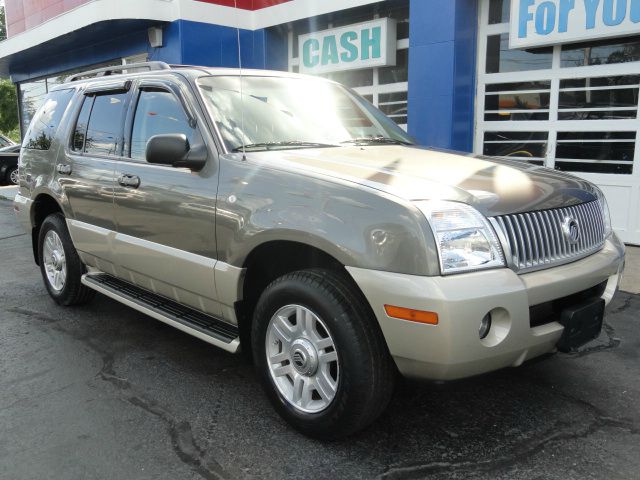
[56,82,130,274]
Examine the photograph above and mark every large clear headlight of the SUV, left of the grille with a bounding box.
[416,201,505,275]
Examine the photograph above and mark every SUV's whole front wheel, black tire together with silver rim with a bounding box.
[252,270,396,440]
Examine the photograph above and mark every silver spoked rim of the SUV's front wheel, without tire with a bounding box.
[265,305,340,413]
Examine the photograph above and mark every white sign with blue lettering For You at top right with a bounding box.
[509,0,640,48]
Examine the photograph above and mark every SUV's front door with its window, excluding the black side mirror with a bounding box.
[110,80,220,315]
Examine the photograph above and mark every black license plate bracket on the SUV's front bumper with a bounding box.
[557,298,604,352]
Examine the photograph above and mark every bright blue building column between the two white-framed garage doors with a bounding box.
[408,0,478,152]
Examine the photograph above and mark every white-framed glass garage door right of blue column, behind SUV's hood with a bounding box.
[474,0,640,243]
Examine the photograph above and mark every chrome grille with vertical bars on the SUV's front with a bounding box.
[491,200,604,273]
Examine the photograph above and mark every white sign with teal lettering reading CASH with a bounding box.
[298,18,397,73]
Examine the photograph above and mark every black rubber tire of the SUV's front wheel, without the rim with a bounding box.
[252,270,396,440]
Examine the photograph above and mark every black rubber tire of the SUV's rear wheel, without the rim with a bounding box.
[38,213,95,306]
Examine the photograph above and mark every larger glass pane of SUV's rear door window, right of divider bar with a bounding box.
[84,93,127,155]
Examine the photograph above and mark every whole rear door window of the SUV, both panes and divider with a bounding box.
[72,93,127,155]
